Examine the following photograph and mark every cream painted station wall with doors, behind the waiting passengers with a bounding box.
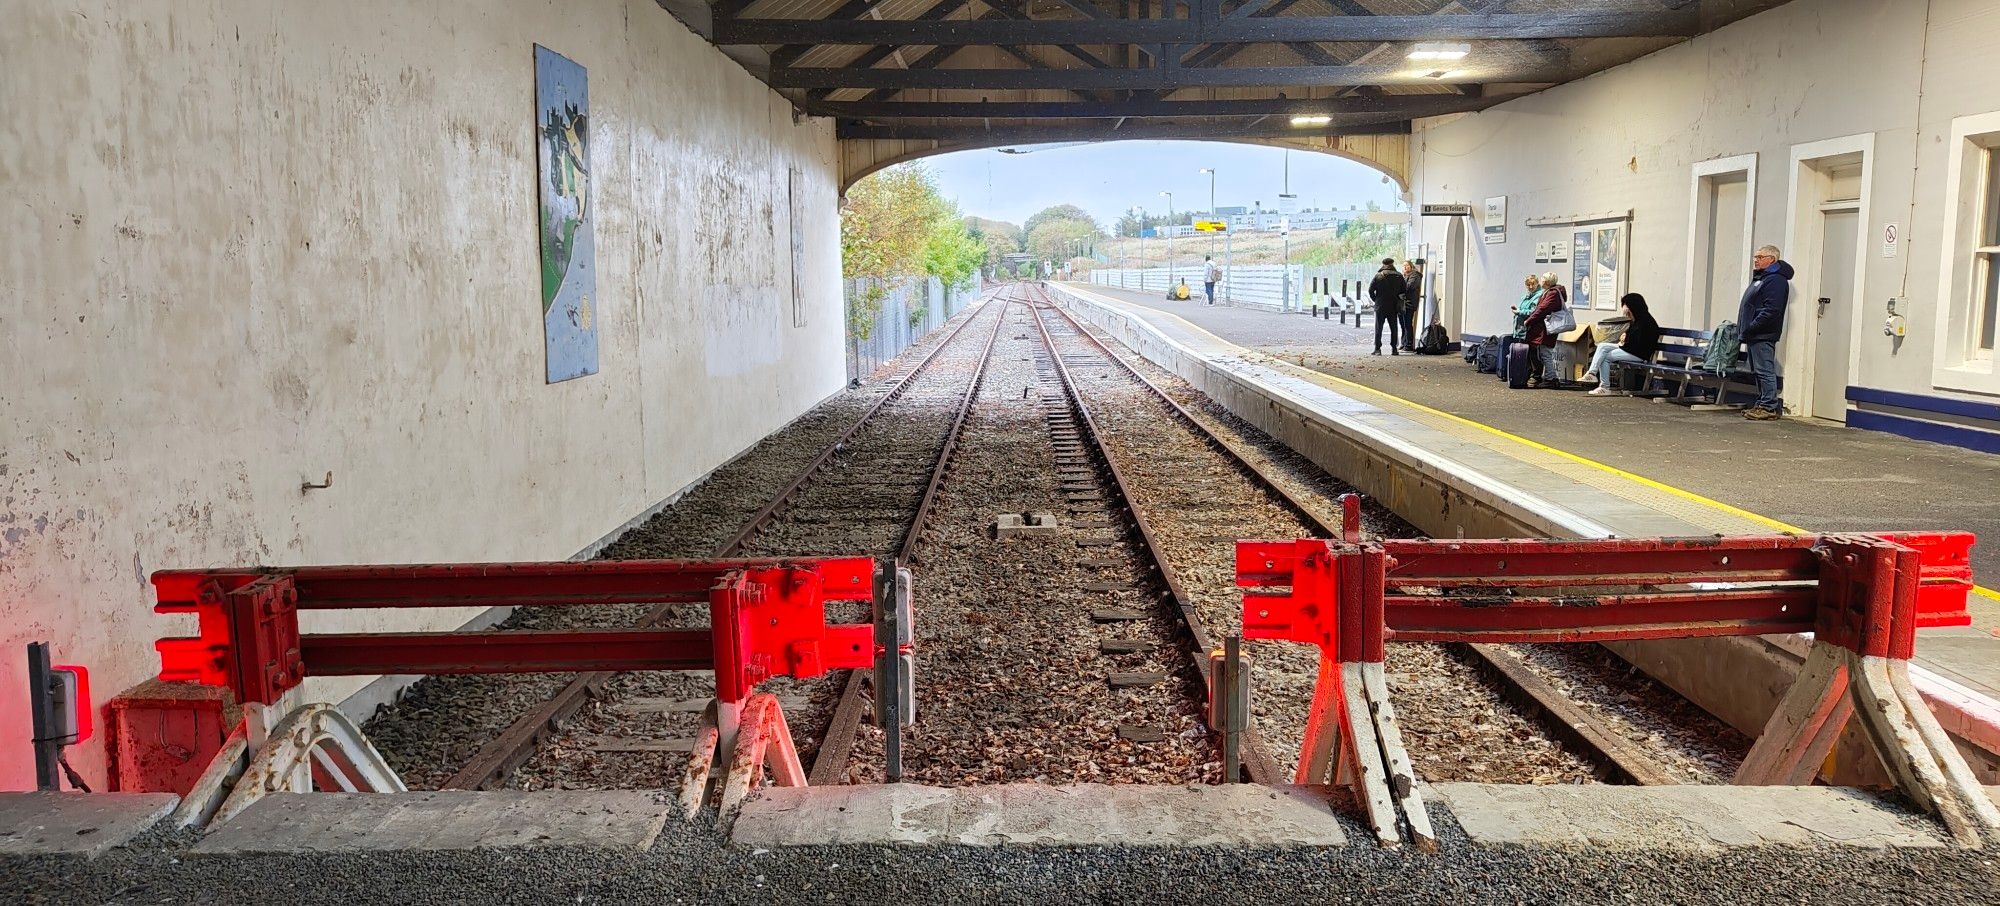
[1410,0,2000,414]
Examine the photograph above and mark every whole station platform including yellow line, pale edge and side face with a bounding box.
[1064,284,2000,776]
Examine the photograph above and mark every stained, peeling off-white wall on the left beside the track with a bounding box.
[0,0,842,788]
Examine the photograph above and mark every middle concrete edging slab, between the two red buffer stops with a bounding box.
[730,784,1346,846]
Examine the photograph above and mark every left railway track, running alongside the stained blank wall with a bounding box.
[444,294,1000,790]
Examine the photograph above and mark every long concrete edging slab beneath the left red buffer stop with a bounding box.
[192,790,674,856]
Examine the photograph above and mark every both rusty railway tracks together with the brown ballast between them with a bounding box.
[398,276,1728,788]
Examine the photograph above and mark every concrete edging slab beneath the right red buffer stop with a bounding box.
[1426,784,1944,850]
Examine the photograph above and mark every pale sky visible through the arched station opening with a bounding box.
[922,142,1398,228]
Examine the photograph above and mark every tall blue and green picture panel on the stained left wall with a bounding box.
[534,44,598,384]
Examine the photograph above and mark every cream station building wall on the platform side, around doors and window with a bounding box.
[1410,0,2000,428]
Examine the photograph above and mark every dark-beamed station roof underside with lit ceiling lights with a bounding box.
[658,0,1784,144]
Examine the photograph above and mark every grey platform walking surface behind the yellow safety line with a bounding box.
[1078,284,2000,608]
